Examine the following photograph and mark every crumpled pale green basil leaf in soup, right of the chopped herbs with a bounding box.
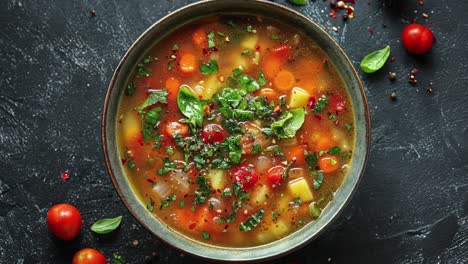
[271,108,305,138]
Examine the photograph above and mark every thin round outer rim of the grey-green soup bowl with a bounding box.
[101,0,371,262]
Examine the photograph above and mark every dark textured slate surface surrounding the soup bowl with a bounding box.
[0,0,468,263]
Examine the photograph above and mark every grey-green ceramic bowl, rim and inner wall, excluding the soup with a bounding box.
[102,0,370,262]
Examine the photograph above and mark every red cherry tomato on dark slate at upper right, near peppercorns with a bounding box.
[401,24,434,54]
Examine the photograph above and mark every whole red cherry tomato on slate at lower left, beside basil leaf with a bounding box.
[47,203,81,240]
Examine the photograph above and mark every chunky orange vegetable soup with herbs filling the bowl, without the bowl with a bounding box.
[117,16,354,247]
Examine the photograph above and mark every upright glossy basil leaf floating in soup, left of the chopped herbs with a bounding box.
[177,86,203,127]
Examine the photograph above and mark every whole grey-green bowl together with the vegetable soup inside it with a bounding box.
[102,0,370,261]
